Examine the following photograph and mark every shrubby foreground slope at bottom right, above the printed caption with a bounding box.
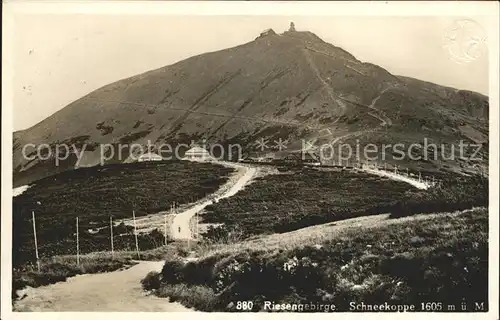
[148,209,488,311]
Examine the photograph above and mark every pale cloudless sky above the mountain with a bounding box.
[12,13,488,130]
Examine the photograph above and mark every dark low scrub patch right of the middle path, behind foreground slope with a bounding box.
[203,169,413,241]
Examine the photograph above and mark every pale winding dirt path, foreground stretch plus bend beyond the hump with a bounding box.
[14,162,258,312]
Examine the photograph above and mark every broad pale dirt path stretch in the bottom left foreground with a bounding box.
[14,261,192,312]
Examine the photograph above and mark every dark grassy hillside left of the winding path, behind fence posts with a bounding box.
[13,161,232,265]
